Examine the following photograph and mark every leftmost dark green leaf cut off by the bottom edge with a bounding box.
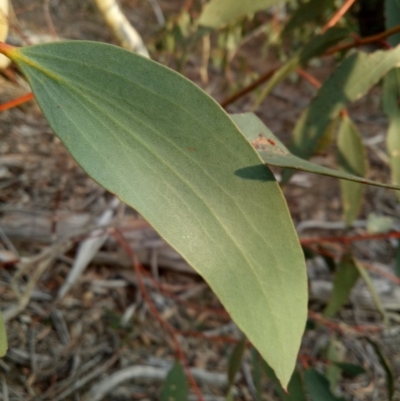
[160,361,189,401]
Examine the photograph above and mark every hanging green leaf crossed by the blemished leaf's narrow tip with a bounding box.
[337,116,368,226]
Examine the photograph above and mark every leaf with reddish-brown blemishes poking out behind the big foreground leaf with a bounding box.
[231,113,400,189]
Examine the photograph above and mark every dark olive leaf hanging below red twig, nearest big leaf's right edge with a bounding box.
[324,255,360,317]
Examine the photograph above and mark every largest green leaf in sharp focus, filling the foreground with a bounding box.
[0,42,307,386]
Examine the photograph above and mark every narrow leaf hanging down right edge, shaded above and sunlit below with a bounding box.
[383,68,400,201]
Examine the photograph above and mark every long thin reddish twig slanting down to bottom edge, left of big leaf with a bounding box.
[114,230,204,401]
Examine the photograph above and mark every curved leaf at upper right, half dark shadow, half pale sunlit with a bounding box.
[289,46,400,166]
